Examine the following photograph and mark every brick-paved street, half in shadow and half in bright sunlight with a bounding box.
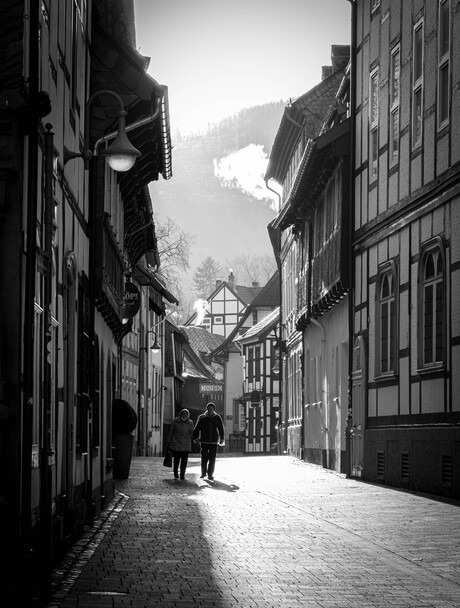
[44,456,460,608]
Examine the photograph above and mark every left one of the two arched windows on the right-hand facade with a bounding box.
[376,262,397,376]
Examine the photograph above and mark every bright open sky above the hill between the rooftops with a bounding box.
[134,0,350,133]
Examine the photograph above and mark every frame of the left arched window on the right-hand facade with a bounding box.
[375,260,399,379]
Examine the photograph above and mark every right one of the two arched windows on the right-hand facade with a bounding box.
[420,239,445,368]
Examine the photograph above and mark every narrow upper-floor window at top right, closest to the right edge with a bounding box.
[438,0,450,128]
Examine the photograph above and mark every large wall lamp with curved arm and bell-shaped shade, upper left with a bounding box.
[64,89,141,172]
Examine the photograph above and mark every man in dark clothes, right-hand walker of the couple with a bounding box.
[193,401,224,481]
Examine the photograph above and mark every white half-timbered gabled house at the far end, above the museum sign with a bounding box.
[185,272,262,337]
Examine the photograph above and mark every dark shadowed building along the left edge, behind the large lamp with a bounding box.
[0,0,171,606]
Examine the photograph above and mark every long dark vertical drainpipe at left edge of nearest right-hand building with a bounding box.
[345,0,358,477]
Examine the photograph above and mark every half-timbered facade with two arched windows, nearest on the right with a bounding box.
[351,0,460,496]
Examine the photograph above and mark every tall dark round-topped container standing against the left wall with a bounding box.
[112,399,137,479]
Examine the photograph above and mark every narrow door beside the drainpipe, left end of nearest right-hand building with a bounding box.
[350,336,366,477]
